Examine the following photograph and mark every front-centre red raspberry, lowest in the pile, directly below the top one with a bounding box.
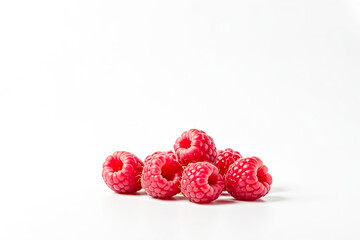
[181,162,225,203]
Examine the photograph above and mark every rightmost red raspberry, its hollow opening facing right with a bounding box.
[225,157,272,200]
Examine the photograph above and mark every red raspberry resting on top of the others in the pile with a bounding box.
[174,129,217,166]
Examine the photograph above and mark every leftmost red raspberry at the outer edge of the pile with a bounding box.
[102,151,144,193]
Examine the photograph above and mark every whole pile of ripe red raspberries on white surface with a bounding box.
[102,129,272,203]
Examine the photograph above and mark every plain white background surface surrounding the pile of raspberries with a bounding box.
[0,0,360,240]
